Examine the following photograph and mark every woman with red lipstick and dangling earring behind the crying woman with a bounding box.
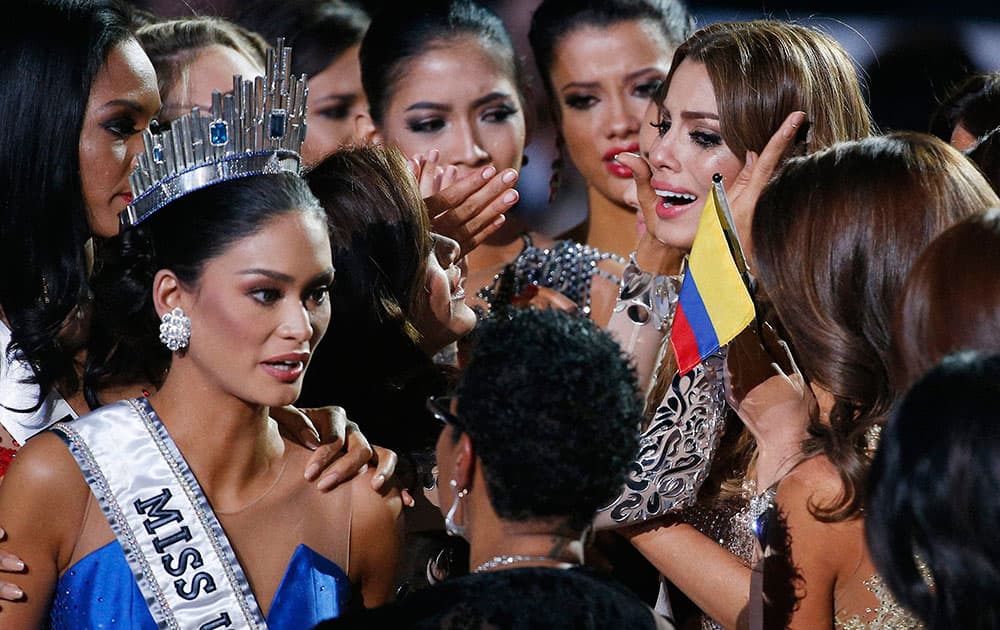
[529,0,694,258]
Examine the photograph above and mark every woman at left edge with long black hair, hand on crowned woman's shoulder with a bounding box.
[0,0,394,488]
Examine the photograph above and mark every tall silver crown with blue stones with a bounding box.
[118,37,308,229]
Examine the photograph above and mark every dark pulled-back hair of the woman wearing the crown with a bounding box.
[85,173,326,402]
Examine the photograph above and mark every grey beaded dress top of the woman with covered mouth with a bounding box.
[477,234,626,315]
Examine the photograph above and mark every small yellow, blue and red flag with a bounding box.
[670,175,755,374]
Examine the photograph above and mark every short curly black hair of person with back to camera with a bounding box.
[457,309,642,531]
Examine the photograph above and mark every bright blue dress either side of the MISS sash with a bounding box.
[49,541,351,630]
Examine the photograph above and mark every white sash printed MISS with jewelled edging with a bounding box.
[52,398,267,630]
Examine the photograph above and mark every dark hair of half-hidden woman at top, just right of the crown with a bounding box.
[233,0,370,77]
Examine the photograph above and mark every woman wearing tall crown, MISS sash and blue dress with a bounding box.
[0,35,401,628]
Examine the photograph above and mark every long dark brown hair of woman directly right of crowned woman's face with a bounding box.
[299,145,443,452]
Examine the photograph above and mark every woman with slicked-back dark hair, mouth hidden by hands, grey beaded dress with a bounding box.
[361,0,624,323]
